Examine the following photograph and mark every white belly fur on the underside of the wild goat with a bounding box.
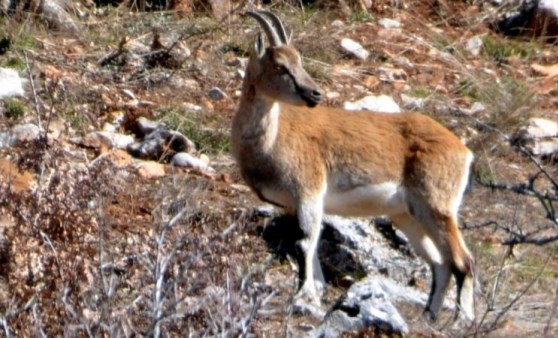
[324,182,407,216]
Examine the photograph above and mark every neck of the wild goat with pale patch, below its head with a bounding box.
[233,85,279,151]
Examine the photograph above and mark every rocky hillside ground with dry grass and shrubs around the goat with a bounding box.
[0,1,558,337]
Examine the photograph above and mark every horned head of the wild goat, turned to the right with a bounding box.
[246,11,322,107]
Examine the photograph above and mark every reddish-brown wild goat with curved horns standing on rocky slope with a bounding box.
[232,11,474,319]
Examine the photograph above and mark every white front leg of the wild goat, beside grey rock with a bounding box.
[296,195,325,305]
